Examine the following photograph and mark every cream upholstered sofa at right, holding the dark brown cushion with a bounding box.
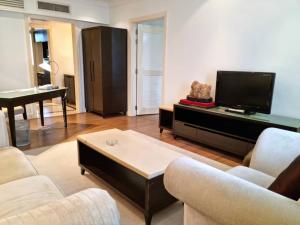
[164,128,300,225]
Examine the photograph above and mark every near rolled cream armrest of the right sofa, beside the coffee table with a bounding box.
[164,158,300,225]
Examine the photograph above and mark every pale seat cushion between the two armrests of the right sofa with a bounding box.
[227,166,275,188]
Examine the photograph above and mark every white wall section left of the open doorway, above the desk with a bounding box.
[0,11,30,91]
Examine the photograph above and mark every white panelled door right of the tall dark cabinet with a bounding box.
[137,24,164,115]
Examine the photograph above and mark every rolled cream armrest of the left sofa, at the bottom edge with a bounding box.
[0,189,120,225]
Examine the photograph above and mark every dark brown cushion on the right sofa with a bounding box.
[269,155,300,201]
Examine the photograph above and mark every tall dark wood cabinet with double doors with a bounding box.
[82,26,127,116]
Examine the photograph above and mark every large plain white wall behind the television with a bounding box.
[110,0,300,118]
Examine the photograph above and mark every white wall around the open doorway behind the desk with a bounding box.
[0,0,109,112]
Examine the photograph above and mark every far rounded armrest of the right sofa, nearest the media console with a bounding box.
[250,128,300,177]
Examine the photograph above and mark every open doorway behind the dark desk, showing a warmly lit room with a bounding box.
[29,19,76,117]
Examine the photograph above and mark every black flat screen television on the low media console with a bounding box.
[216,71,276,114]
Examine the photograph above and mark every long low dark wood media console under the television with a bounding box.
[173,104,300,156]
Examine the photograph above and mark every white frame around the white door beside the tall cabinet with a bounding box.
[127,12,168,116]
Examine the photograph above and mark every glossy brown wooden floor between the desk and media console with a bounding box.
[22,113,241,166]
